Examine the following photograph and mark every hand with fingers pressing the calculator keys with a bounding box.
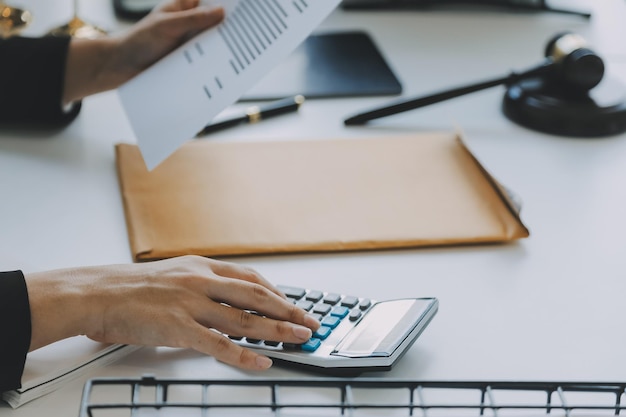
[26,256,319,370]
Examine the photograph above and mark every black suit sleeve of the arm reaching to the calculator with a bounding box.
[0,271,31,392]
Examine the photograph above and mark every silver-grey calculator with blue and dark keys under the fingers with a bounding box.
[232,285,439,376]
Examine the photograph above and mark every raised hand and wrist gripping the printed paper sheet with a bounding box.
[63,0,224,104]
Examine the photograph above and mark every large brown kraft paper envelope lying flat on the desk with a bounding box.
[116,133,529,261]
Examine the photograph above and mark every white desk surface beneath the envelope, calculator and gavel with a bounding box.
[0,0,626,416]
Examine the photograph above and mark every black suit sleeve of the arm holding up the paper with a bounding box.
[0,36,80,126]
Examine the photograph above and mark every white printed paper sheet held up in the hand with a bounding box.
[119,0,340,169]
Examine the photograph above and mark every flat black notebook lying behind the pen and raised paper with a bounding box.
[241,32,402,101]
